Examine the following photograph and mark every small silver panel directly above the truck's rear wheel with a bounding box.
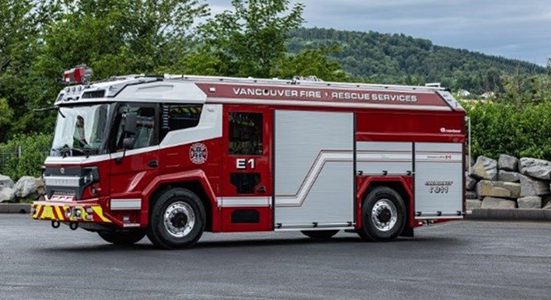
[356,142,413,175]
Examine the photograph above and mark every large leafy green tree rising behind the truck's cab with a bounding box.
[18,0,208,135]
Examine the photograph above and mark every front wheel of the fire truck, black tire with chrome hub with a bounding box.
[147,188,206,249]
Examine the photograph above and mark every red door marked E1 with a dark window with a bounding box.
[217,106,273,231]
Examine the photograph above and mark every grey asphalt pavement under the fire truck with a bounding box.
[0,215,551,299]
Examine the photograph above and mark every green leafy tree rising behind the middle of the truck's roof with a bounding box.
[195,0,304,77]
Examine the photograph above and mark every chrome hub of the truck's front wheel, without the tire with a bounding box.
[163,201,195,238]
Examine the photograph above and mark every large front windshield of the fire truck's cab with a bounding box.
[51,104,113,156]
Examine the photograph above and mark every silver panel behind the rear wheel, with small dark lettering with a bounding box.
[415,143,463,219]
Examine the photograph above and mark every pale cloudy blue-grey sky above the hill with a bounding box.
[207,0,551,65]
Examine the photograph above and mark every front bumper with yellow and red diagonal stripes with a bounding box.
[31,201,112,223]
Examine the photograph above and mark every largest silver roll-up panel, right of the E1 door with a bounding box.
[275,110,354,229]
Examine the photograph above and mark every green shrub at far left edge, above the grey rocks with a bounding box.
[0,134,52,181]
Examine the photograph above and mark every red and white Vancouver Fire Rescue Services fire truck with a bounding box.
[32,67,466,249]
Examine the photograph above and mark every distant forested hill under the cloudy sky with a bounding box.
[288,28,545,94]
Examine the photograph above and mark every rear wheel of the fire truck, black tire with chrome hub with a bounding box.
[358,187,406,241]
